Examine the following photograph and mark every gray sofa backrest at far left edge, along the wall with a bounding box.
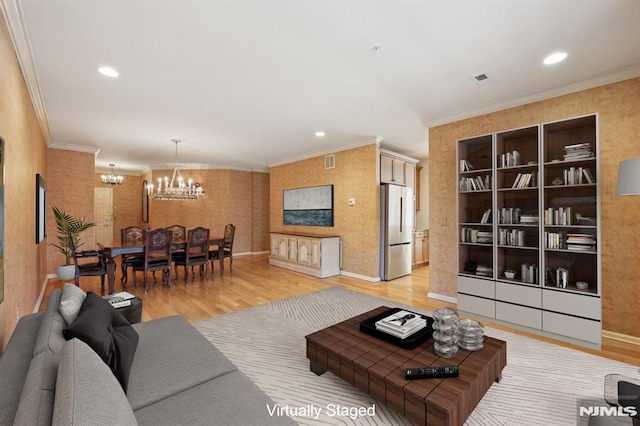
[0,312,44,426]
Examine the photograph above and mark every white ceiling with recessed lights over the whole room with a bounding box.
[1,0,640,171]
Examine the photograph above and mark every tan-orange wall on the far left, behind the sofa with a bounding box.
[0,19,47,353]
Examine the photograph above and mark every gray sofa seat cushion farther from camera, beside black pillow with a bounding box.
[127,316,237,411]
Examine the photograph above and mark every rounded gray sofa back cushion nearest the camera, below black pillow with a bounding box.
[52,339,138,426]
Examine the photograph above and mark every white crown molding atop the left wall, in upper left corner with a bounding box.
[0,0,51,146]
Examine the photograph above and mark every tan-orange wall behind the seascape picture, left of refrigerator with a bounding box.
[270,144,380,279]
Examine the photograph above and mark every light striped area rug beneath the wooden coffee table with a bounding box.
[194,287,639,426]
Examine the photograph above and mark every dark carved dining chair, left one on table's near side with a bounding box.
[132,228,173,293]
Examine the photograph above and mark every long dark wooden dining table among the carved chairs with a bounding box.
[98,237,224,294]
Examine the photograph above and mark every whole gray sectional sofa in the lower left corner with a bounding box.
[0,290,295,426]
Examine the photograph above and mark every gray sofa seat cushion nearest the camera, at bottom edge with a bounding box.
[134,371,297,426]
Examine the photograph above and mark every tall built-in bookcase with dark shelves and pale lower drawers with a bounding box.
[457,114,601,347]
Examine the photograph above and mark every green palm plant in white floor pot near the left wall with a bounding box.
[51,206,96,281]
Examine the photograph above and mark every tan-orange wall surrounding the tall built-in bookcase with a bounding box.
[429,78,640,337]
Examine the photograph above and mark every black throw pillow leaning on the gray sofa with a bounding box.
[63,292,138,392]
